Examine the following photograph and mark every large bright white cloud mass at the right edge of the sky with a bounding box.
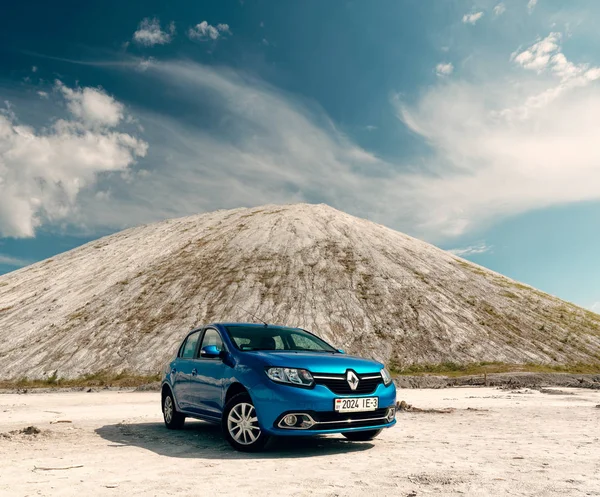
[395,30,600,236]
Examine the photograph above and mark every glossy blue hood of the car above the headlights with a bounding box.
[246,351,383,374]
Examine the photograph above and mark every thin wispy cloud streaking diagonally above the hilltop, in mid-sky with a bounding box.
[74,62,390,232]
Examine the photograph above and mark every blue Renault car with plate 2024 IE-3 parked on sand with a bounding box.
[161,323,396,452]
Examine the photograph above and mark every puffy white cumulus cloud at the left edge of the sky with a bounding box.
[0,82,147,237]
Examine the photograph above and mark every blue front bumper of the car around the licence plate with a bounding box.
[250,383,396,436]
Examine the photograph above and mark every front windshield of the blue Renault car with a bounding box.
[227,326,337,352]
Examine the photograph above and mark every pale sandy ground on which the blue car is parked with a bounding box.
[0,388,600,497]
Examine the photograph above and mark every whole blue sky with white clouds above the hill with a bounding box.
[0,0,600,311]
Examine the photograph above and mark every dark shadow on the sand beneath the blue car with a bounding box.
[95,420,373,459]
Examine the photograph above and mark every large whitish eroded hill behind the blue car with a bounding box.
[0,204,600,380]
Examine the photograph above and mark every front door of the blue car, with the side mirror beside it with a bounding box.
[190,328,229,417]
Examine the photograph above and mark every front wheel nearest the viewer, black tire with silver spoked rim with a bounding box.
[221,393,269,452]
